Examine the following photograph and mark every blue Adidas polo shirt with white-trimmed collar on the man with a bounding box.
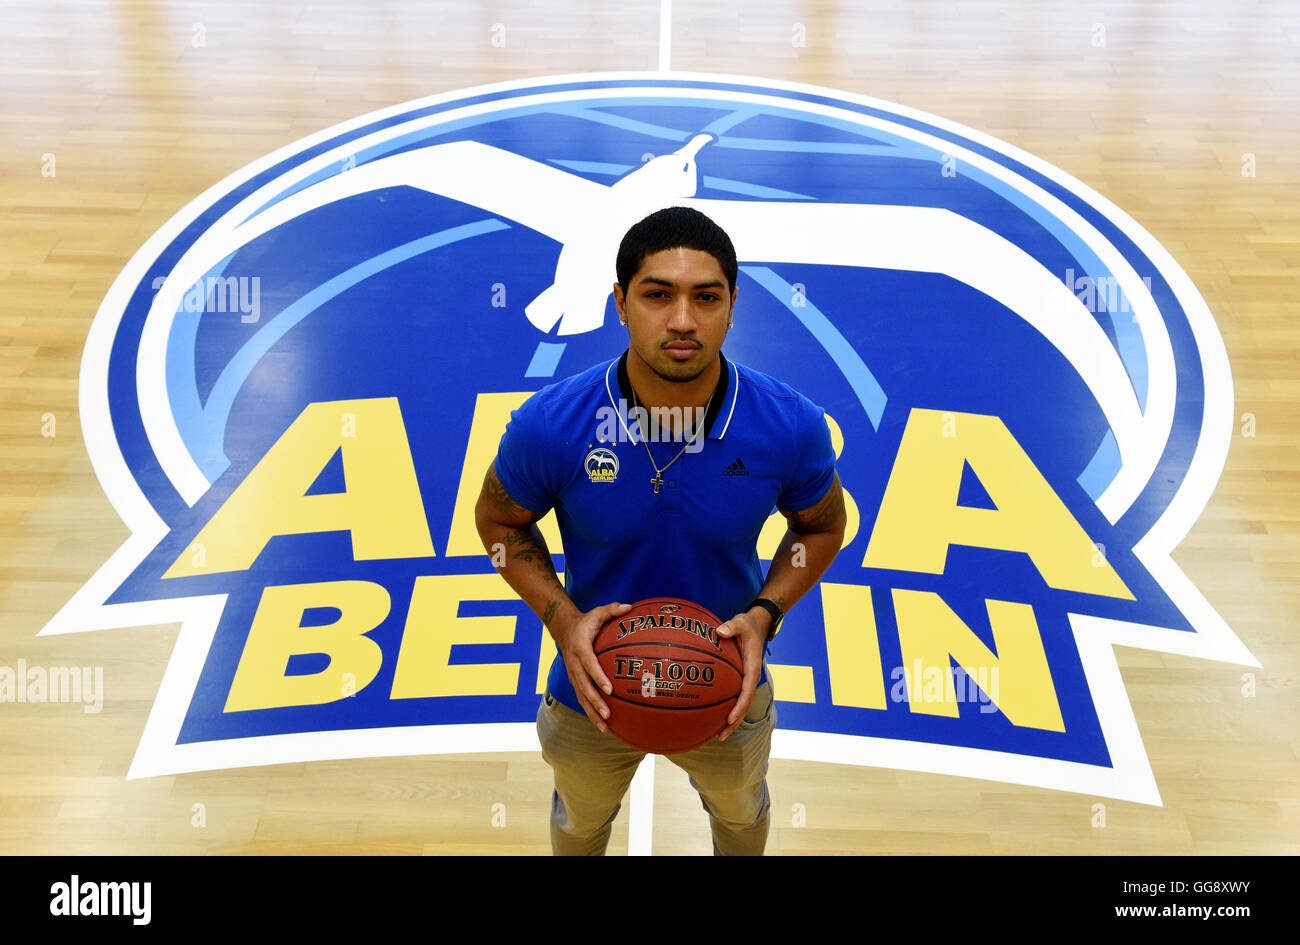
[495,351,835,712]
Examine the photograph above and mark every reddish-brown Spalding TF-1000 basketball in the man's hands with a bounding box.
[592,597,744,755]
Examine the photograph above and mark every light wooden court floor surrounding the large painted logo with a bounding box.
[0,0,1300,854]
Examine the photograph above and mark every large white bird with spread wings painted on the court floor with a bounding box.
[144,134,1173,515]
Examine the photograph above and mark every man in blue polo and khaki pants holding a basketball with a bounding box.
[475,207,845,855]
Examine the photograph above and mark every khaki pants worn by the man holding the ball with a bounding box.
[537,671,776,857]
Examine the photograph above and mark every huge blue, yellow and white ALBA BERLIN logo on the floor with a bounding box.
[43,73,1257,803]
